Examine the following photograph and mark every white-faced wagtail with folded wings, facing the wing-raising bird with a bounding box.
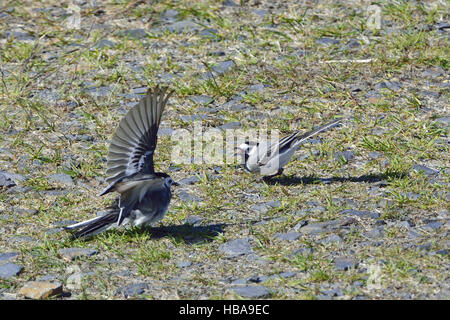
[238,118,343,177]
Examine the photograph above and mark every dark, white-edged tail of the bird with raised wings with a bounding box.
[64,210,119,239]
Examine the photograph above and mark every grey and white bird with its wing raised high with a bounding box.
[65,86,177,238]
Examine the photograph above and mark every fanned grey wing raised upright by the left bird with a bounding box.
[101,86,173,195]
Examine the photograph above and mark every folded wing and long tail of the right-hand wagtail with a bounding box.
[258,118,343,166]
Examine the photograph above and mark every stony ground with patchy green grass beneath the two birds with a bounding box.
[0,0,450,299]
